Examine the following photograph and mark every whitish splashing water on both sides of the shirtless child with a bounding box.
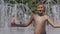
[0,0,60,34]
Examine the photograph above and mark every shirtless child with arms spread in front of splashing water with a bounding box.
[11,4,60,34]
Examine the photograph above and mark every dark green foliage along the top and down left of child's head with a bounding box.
[9,0,52,14]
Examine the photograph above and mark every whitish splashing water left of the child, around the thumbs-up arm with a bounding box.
[0,0,32,34]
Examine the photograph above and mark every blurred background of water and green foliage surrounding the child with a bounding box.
[0,0,60,34]
